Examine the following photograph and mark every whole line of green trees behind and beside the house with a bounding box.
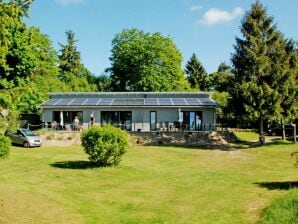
[0,0,298,136]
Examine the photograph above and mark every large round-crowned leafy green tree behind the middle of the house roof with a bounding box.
[107,29,189,91]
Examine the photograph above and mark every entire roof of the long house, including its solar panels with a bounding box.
[40,92,217,108]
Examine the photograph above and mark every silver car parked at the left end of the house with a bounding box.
[4,128,42,148]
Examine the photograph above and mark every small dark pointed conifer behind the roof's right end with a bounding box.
[185,54,208,91]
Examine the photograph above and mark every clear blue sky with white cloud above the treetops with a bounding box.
[26,0,298,75]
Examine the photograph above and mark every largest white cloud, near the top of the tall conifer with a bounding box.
[200,7,244,26]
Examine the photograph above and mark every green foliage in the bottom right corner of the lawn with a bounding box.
[260,188,298,224]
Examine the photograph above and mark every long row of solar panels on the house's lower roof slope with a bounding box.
[41,97,216,107]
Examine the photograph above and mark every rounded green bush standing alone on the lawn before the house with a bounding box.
[81,125,128,166]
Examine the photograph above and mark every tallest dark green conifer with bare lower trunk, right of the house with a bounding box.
[230,1,294,143]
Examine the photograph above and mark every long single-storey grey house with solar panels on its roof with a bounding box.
[40,92,217,132]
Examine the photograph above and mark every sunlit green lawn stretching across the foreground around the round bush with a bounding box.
[0,144,298,224]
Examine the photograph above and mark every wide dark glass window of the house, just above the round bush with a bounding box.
[101,111,131,131]
